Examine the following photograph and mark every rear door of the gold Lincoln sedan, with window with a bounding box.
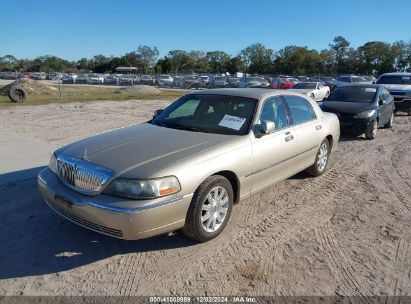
[284,95,323,171]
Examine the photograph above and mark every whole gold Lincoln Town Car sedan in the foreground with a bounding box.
[38,88,340,242]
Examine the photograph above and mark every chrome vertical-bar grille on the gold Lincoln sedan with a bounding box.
[57,155,114,194]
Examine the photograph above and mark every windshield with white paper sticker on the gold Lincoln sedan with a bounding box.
[150,94,257,135]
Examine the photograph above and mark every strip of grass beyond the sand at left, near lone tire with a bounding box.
[0,86,189,107]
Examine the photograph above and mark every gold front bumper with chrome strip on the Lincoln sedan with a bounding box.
[38,168,193,240]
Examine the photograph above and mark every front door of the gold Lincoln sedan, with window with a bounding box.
[251,96,296,192]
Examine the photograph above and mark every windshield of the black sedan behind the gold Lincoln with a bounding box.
[326,86,377,103]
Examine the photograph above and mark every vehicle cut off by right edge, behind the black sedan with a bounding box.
[376,73,411,116]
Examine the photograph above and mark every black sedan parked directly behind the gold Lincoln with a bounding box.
[320,84,394,139]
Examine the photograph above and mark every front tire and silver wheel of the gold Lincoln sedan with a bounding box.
[182,175,234,242]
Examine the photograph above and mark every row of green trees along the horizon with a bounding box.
[0,36,411,75]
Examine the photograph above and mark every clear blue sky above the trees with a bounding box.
[0,0,411,60]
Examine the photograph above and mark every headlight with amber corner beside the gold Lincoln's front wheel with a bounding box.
[104,176,181,199]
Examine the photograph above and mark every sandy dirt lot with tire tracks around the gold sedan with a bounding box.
[0,101,411,301]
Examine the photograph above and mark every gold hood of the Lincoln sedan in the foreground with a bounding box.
[56,123,238,178]
